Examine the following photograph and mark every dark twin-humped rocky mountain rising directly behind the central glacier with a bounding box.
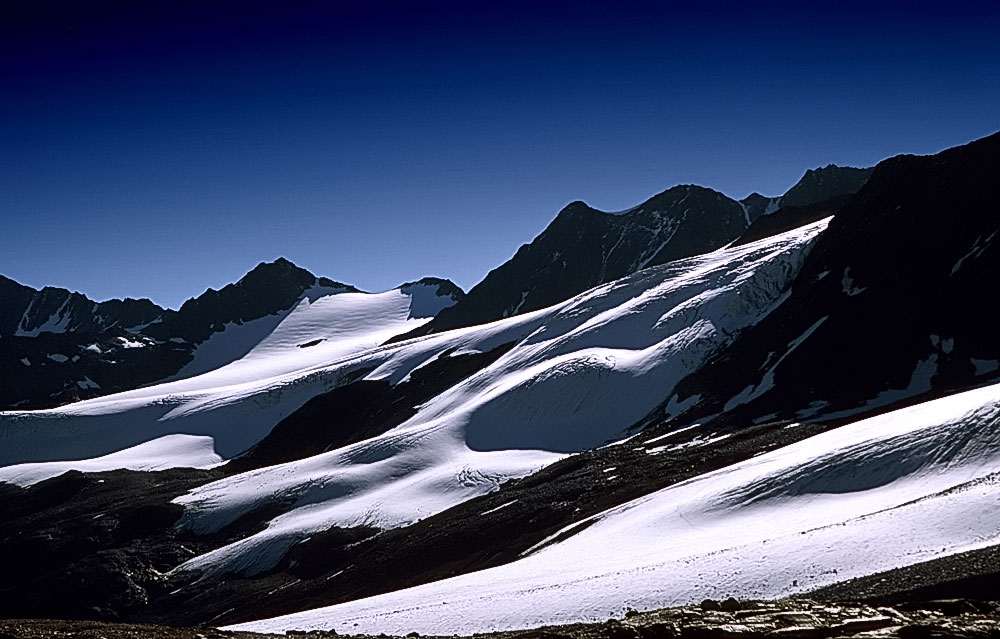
[396,164,871,339]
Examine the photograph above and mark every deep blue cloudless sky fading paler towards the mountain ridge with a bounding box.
[0,0,1000,308]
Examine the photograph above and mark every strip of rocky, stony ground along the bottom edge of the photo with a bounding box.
[0,599,1000,639]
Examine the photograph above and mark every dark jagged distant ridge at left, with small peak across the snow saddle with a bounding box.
[0,258,463,409]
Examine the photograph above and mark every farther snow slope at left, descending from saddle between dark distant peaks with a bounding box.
[0,288,458,470]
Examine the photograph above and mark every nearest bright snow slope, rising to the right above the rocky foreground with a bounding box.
[232,385,1000,635]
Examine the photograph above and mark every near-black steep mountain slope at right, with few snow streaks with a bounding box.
[653,134,1000,425]
